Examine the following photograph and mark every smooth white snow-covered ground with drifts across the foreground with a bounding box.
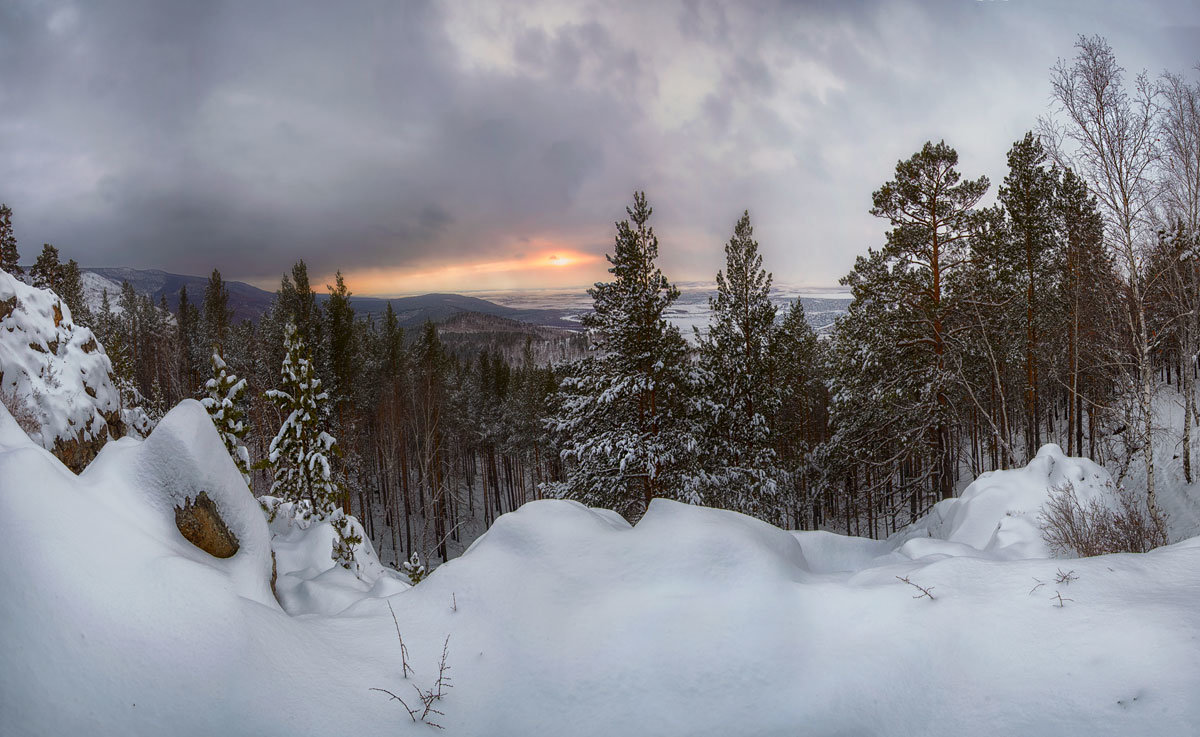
[0,402,1200,737]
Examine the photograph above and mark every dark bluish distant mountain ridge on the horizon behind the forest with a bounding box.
[83,266,580,330]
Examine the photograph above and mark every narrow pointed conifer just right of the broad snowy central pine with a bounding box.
[700,211,780,521]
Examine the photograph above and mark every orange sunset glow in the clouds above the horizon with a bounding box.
[324,247,605,296]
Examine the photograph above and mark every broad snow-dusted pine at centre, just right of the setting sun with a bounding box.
[547,192,701,519]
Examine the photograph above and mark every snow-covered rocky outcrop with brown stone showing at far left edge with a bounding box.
[0,271,124,471]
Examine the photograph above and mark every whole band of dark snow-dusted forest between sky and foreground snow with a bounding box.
[2,37,1200,563]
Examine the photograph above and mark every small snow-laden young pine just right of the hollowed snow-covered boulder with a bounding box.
[265,323,362,570]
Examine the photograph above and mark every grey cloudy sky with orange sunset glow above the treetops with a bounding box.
[0,0,1200,294]
